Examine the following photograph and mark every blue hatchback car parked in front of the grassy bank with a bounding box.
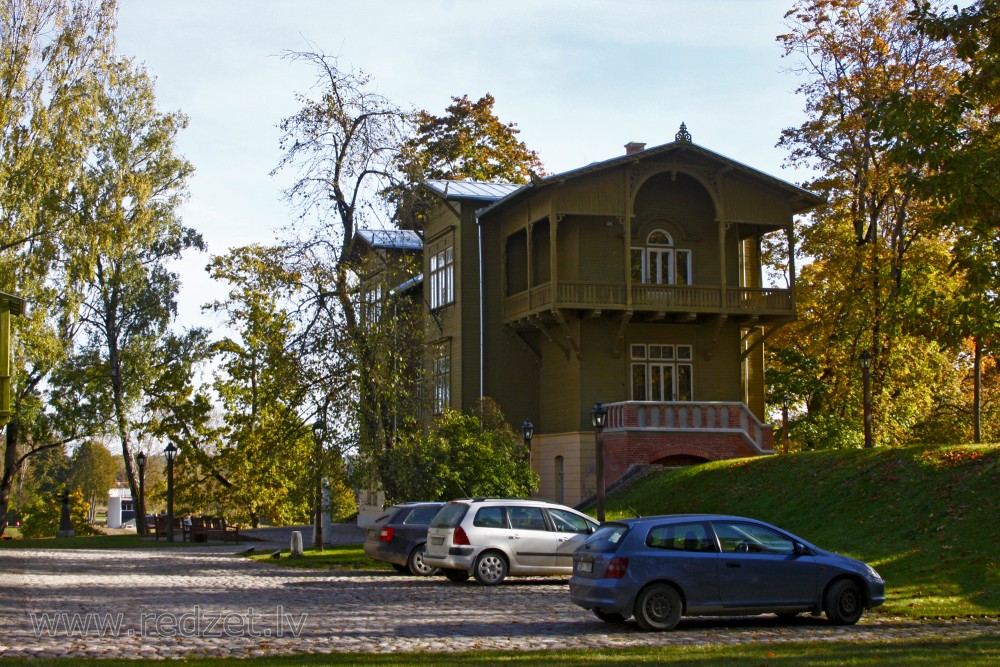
[569,514,885,630]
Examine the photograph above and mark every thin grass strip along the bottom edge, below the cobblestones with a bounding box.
[1,636,1000,667]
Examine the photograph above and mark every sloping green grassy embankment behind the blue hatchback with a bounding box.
[608,445,1000,617]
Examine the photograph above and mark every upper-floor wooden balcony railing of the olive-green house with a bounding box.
[504,281,795,323]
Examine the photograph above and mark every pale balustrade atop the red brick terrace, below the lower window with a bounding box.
[605,401,771,454]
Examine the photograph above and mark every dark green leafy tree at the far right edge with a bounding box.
[879,0,1000,442]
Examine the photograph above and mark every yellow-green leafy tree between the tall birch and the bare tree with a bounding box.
[203,246,314,525]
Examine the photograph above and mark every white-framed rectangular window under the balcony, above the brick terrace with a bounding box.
[629,343,694,401]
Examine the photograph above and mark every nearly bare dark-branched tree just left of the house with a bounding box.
[275,52,409,496]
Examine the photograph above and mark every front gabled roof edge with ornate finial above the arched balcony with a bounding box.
[477,136,824,215]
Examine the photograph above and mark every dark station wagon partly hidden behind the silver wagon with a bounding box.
[365,502,444,576]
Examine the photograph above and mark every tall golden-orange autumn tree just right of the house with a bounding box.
[774,0,960,444]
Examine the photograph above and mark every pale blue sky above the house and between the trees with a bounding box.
[118,0,804,326]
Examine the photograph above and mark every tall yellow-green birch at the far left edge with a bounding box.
[0,0,117,533]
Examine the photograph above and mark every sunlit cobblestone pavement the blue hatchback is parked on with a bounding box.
[0,546,1000,659]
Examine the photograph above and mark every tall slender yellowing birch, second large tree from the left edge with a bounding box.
[51,60,204,533]
